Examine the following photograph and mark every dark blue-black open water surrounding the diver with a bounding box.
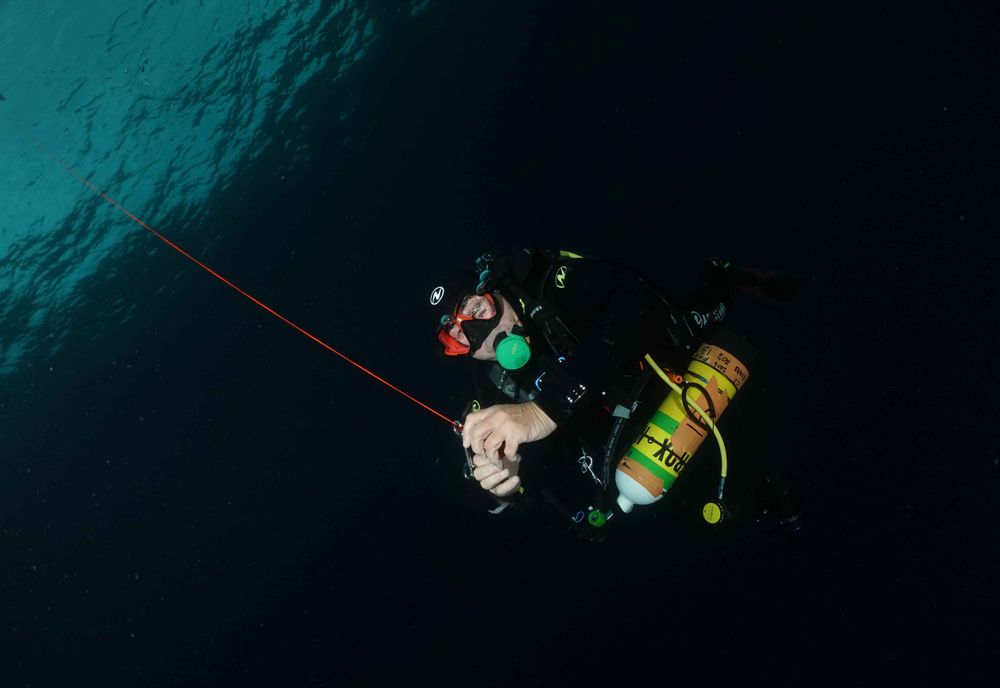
[0,1,1000,686]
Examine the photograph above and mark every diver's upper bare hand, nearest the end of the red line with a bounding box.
[462,401,556,459]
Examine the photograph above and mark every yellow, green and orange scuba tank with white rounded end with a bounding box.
[615,328,757,524]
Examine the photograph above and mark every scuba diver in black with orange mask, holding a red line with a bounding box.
[429,249,797,539]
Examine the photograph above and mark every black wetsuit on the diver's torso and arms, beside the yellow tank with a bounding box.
[462,250,729,528]
